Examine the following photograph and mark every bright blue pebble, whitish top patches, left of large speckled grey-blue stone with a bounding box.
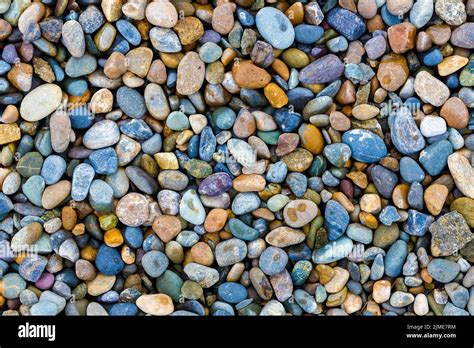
[342,129,387,163]
